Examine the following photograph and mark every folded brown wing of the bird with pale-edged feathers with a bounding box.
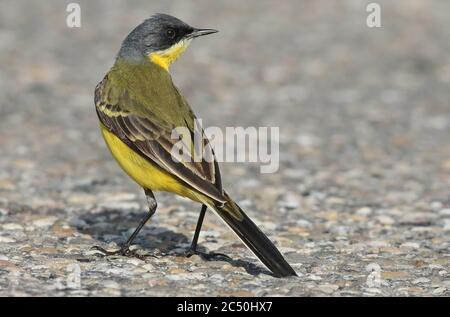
[95,77,227,204]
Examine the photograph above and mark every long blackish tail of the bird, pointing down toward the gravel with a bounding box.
[214,195,297,277]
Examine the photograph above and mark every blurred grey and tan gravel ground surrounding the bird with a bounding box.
[0,0,450,296]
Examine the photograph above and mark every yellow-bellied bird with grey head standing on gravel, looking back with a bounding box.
[95,14,297,277]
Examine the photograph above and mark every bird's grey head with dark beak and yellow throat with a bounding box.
[117,14,217,70]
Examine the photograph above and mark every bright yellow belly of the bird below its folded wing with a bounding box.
[100,124,204,202]
